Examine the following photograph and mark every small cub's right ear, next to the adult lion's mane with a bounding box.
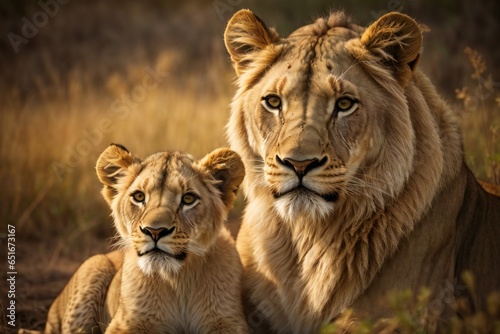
[200,148,245,209]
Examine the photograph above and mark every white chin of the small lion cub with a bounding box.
[137,252,187,279]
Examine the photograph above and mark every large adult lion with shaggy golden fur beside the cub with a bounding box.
[225,10,500,333]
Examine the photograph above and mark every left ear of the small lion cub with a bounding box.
[95,144,140,204]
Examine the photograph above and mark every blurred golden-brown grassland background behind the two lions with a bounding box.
[0,0,500,327]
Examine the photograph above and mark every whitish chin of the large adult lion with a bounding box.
[274,191,337,221]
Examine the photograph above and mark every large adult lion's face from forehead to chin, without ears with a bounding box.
[245,47,381,217]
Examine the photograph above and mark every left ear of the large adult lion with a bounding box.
[224,9,279,75]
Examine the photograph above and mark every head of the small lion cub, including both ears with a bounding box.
[96,145,244,276]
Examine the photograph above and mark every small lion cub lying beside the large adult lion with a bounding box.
[41,144,247,334]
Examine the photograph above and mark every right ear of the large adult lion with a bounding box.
[361,12,422,86]
